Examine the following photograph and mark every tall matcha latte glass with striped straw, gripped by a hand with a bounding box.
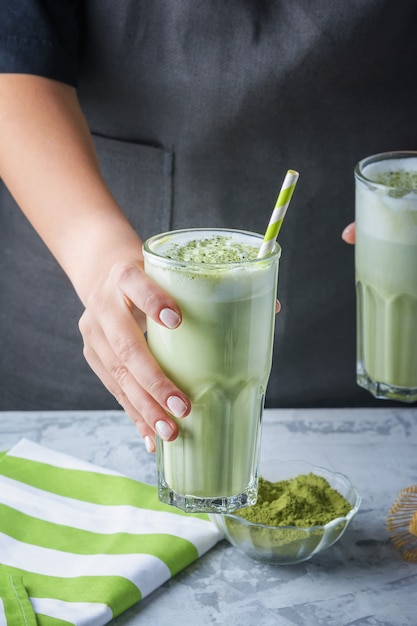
[144,229,281,513]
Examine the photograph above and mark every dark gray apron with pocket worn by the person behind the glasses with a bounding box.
[0,0,417,410]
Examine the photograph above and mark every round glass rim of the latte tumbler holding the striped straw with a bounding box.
[143,227,282,269]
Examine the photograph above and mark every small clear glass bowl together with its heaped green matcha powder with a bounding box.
[212,461,360,565]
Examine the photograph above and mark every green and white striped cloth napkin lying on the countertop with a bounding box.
[0,439,222,626]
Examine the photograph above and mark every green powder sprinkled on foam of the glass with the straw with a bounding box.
[164,235,259,263]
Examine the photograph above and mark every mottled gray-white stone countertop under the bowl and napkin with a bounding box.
[0,404,417,626]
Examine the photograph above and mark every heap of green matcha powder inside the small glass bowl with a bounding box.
[235,473,352,528]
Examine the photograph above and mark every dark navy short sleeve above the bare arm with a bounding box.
[0,0,82,86]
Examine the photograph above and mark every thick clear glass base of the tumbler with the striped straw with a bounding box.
[158,472,258,513]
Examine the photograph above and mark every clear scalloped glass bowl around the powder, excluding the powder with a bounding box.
[210,461,361,565]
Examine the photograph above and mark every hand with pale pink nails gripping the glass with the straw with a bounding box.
[79,258,190,452]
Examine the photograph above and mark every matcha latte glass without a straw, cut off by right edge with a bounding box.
[355,152,417,402]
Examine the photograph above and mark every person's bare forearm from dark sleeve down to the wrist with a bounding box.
[0,74,141,302]
